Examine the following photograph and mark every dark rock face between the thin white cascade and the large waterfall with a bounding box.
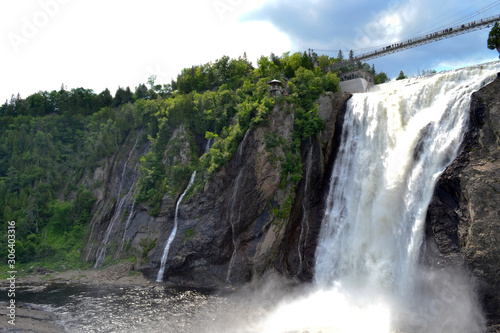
[144,94,350,286]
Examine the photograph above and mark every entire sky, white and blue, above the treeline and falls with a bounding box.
[0,0,500,101]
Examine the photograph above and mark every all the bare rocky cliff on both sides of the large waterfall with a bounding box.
[79,71,500,323]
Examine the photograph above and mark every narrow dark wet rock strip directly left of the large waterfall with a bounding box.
[278,93,352,281]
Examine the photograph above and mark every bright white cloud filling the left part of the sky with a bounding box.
[0,0,290,101]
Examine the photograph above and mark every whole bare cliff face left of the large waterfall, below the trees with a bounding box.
[84,93,351,286]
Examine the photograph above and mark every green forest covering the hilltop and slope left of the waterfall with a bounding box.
[0,52,388,269]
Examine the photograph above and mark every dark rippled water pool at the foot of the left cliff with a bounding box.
[0,284,270,333]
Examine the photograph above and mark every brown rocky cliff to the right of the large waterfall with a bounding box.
[424,76,500,323]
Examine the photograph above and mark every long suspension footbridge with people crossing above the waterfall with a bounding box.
[311,15,500,70]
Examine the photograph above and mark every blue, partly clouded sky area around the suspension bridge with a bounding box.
[242,0,497,77]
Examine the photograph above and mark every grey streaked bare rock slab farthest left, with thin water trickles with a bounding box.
[82,132,151,267]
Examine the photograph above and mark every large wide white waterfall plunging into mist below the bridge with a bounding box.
[264,63,499,333]
